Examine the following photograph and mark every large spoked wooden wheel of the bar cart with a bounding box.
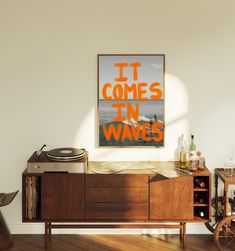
[214,215,235,251]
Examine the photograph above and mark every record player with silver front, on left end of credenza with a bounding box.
[27,148,88,173]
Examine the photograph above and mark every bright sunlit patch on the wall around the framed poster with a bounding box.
[73,73,188,160]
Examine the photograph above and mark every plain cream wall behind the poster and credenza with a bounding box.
[0,0,235,233]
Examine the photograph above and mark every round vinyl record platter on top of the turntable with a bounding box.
[47,147,86,161]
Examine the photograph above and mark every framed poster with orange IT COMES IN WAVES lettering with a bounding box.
[97,54,165,147]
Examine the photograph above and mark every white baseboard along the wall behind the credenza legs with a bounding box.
[8,223,210,234]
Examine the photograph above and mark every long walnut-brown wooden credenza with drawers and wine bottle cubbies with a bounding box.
[22,162,211,244]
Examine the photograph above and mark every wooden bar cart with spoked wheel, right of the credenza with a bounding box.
[206,168,235,251]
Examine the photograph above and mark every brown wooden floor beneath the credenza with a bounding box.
[2,234,217,251]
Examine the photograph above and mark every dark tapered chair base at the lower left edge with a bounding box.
[0,211,13,249]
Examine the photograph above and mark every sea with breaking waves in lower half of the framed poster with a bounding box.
[99,99,164,147]
